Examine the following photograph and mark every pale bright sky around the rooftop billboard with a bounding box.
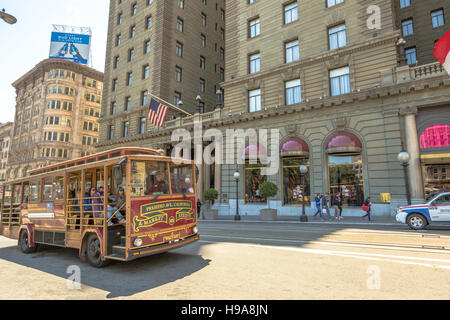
[0,0,109,123]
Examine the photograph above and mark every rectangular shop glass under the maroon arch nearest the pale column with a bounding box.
[328,153,364,207]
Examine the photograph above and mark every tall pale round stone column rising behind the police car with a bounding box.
[400,106,425,204]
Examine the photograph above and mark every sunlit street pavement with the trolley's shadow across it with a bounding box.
[0,219,450,300]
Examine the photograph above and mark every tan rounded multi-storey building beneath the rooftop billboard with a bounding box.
[7,59,103,180]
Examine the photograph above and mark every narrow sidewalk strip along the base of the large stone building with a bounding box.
[199,215,400,226]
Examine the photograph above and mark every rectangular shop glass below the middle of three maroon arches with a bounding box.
[283,157,311,205]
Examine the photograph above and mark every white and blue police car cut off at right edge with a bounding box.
[395,192,450,230]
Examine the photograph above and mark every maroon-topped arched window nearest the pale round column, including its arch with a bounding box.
[326,131,364,206]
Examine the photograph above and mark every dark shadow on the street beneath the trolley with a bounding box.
[0,244,211,298]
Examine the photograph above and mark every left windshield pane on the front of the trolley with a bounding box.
[131,161,169,197]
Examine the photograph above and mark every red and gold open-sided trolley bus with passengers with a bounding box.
[0,148,199,267]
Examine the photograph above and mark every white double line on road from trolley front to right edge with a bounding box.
[200,240,450,270]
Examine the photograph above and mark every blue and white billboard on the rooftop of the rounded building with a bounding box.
[49,32,91,65]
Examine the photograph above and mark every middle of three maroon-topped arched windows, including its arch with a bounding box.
[280,138,311,205]
